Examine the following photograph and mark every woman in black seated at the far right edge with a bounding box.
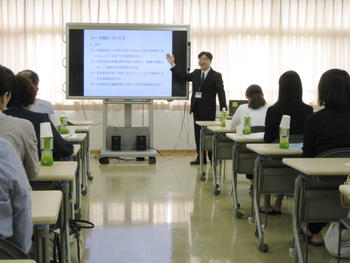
[303,69,350,246]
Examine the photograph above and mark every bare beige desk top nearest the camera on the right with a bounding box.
[282,158,350,175]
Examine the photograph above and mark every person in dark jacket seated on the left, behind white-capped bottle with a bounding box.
[4,76,74,160]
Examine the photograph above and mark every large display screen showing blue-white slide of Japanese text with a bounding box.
[66,23,190,100]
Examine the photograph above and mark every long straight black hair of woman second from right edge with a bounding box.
[277,70,303,105]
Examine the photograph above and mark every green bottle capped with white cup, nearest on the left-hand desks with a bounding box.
[40,122,53,166]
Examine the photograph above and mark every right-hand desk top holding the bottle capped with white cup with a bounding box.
[246,143,303,155]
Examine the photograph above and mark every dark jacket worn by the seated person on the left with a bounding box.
[3,108,74,160]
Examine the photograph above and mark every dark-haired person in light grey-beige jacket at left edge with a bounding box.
[0,65,40,186]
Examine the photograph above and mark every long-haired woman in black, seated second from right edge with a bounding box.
[260,71,313,214]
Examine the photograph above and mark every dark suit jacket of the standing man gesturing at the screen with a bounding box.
[171,66,227,120]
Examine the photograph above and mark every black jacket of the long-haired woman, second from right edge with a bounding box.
[264,103,313,143]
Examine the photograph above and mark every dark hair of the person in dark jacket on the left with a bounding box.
[7,76,36,109]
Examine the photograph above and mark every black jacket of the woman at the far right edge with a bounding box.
[303,108,350,157]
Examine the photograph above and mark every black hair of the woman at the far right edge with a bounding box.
[318,69,350,109]
